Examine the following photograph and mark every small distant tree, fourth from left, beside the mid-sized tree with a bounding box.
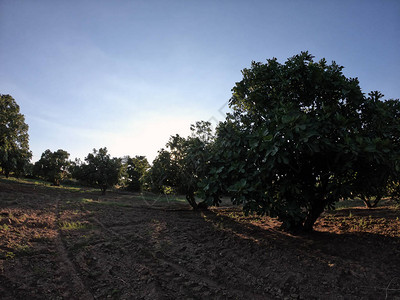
[122,156,150,192]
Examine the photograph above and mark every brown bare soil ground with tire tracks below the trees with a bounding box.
[0,179,400,299]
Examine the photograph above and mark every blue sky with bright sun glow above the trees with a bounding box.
[0,0,400,161]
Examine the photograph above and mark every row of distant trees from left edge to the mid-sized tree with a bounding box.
[0,95,150,194]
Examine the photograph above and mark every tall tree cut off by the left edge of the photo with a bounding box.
[0,94,32,177]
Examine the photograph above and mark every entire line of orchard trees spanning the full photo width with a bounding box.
[0,52,400,231]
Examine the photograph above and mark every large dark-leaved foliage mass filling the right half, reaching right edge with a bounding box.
[201,52,399,231]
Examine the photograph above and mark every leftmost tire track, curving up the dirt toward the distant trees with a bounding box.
[55,195,94,299]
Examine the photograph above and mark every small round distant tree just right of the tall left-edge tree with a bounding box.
[33,149,70,186]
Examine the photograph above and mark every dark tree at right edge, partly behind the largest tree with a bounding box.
[353,91,400,208]
